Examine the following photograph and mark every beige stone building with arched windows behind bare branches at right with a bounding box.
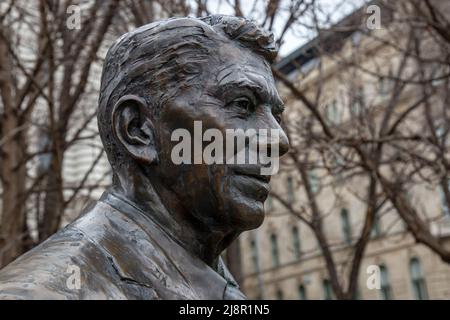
[239,1,450,299]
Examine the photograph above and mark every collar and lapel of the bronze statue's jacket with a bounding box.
[93,192,245,299]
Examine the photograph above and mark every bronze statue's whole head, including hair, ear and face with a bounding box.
[98,15,288,232]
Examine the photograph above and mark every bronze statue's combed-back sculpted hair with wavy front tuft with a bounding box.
[97,15,277,168]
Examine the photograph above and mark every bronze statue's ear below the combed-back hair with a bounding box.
[112,95,158,165]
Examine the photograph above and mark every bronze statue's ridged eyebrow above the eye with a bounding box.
[219,77,284,113]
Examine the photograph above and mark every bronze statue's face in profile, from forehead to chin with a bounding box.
[155,43,288,231]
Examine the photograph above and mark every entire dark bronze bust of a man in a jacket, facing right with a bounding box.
[0,15,289,299]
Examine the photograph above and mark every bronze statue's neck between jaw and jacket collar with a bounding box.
[112,167,238,270]
